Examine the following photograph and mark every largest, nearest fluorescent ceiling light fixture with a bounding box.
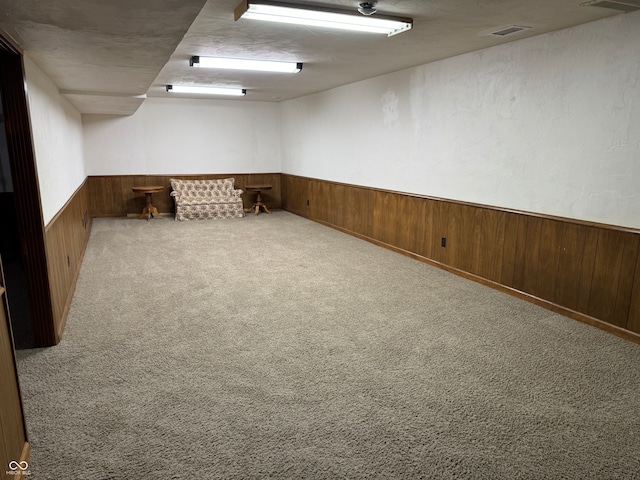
[234,0,413,37]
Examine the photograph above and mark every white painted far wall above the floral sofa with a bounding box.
[83,98,281,175]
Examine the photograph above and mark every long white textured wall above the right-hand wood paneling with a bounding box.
[282,12,640,228]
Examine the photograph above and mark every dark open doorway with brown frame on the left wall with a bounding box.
[0,32,58,348]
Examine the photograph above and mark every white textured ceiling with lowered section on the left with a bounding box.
[0,0,622,115]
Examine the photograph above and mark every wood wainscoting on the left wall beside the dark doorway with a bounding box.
[45,180,91,343]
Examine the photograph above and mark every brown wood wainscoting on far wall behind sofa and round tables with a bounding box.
[88,173,282,217]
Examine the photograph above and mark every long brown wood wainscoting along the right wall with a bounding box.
[282,174,640,343]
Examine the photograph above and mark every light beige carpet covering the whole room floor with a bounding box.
[13,211,640,479]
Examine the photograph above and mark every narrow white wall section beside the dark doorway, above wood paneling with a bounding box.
[24,56,87,225]
